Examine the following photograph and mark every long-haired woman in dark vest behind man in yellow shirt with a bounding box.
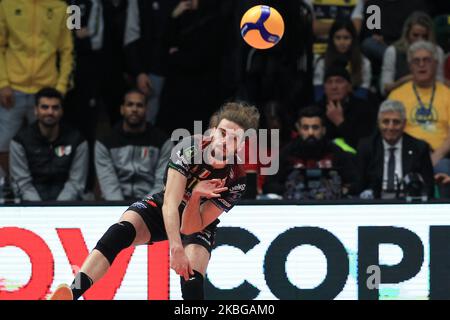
[380,11,444,95]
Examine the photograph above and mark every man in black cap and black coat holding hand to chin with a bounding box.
[319,65,376,149]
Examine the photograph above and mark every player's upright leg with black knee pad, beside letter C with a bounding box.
[180,243,210,300]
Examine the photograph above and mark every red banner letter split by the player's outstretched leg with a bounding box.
[56,229,134,300]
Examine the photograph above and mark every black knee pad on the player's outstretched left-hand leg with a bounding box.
[95,221,136,265]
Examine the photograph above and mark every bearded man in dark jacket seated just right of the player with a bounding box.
[264,106,356,200]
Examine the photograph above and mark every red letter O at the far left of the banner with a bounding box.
[0,227,54,300]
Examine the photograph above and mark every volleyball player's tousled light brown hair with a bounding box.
[214,102,259,131]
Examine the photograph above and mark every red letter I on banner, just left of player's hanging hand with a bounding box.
[147,241,169,300]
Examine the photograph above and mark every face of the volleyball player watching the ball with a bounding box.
[211,119,244,161]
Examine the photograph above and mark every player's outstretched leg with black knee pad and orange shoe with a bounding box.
[51,210,151,300]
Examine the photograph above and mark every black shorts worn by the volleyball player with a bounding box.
[128,197,219,254]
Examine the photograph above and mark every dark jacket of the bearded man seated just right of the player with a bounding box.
[264,138,356,195]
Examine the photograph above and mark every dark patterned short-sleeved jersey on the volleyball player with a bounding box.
[153,135,246,214]
